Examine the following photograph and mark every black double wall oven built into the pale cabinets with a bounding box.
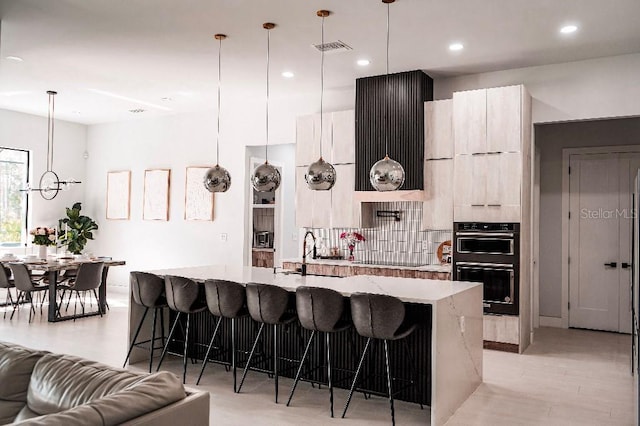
[453,222,520,315]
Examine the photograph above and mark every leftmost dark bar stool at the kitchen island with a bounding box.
[122,271,168,373]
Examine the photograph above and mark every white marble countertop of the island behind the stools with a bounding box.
[149,265,482,304]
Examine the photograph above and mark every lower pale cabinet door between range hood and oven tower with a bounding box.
[422,158,453,230]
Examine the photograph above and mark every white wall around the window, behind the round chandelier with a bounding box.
[0,109,87,252]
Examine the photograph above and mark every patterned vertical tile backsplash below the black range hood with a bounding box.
[307,201,453,266]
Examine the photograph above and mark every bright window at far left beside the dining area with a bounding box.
[0,147,29,247]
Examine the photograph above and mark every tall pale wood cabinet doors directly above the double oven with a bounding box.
[453,85,531,222]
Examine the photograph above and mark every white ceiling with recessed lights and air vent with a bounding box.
[0,0,640,124]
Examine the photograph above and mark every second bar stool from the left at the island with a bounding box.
[156,275,207,383]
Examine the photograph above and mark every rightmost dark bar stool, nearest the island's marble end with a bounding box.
[342,293,422,425]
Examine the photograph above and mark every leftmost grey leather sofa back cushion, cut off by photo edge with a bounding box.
[0,342,46,424]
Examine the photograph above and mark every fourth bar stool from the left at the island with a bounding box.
[238,283,296,403]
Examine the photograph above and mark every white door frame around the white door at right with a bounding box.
[561,145,640,328]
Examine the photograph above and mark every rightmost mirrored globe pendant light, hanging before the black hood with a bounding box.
[369,0,405,191]
